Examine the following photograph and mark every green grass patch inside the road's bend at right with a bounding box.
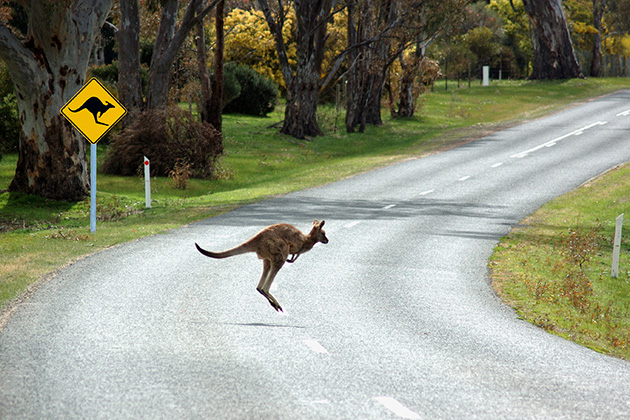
[490,164,630,360]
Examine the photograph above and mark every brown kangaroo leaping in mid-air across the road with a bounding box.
[195,220,328,312]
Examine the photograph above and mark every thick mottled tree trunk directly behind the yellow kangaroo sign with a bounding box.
[0,0,113,201]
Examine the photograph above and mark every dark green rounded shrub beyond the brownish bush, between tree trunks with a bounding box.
[223,63,278,117]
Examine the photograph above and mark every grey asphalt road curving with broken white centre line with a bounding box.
[0,91,630,419]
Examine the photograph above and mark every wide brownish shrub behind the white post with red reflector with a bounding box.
[102,107,223,178]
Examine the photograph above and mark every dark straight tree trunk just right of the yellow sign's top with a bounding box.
[116,0,144,118]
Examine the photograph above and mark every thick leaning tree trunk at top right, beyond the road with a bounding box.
[523,0,584,80]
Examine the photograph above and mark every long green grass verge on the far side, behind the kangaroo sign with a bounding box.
[0,79,630,314]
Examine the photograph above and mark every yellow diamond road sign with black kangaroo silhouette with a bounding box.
[61,77,127,144]
